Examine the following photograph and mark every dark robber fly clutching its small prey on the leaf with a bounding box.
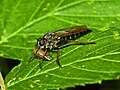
[29,26,95,67]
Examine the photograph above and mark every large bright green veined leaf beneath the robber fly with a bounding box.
[0,0,120,90]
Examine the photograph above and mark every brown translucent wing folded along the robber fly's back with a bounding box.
[54,26,91,40]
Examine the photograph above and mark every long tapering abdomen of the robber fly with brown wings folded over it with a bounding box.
[56,26,92,46]
